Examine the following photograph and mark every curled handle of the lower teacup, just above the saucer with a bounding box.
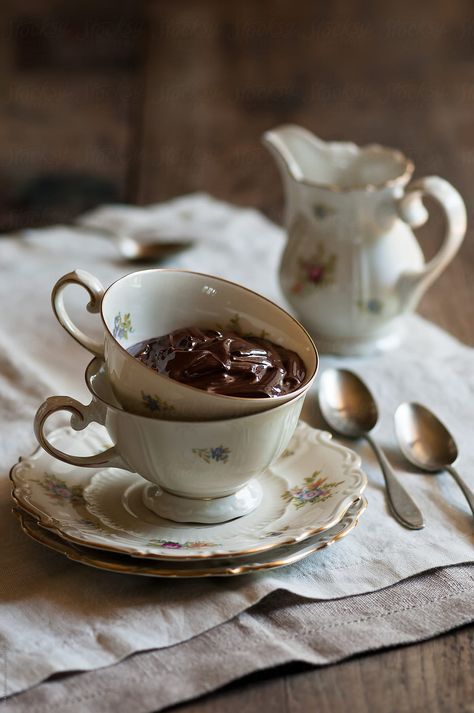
[34,396,130,470]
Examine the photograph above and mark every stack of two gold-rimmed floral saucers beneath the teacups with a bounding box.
[11,423,366,577]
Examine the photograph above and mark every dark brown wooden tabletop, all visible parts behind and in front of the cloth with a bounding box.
[0,0,474,713]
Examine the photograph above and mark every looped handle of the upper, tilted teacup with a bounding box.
[51,270,104,357]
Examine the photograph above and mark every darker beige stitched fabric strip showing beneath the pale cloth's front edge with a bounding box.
[4,565,474,713]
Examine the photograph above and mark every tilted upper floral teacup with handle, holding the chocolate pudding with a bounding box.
[52,269,318,421]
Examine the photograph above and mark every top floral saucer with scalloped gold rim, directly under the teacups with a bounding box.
[10,423,367,560]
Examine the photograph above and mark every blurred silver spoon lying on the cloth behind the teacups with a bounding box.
[73,224,194,263]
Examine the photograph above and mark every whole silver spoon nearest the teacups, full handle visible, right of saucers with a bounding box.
[319,369,425,530]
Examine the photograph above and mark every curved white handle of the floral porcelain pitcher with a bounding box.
[397,176,467,310]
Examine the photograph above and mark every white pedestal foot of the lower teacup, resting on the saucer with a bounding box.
[143,480,262,524]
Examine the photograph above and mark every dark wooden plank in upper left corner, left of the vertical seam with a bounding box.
[0,0,145,231]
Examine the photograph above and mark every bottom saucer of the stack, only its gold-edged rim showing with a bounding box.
[14,497,367,579]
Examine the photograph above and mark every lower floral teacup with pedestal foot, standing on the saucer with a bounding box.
[35,358,306,523]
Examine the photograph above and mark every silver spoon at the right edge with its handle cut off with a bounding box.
[395,403,474,514]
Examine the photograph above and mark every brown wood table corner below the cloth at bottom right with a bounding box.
[173,627,474,713]
